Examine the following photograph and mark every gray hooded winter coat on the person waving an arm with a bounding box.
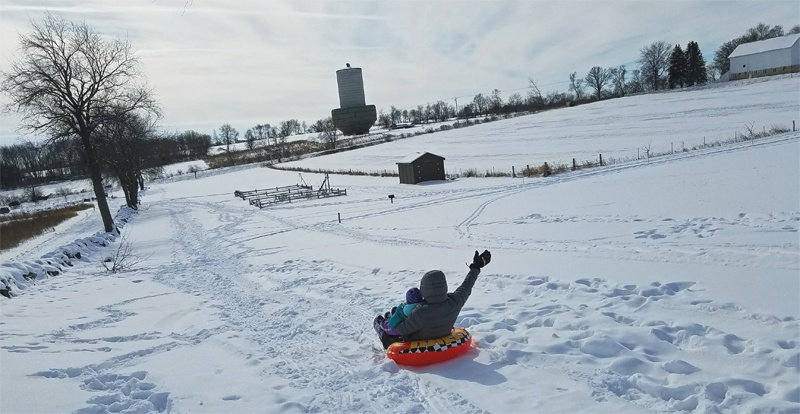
[395,269,481,341]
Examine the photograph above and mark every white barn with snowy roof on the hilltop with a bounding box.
[728,34,800,80]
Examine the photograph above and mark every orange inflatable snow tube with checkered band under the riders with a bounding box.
[386,328,472,366]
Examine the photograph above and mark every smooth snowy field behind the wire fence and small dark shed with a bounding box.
[284,74,800,175]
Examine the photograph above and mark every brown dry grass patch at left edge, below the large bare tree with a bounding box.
[0,204,93,250]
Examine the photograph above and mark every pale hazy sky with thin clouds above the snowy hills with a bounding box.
[0,0,800,145]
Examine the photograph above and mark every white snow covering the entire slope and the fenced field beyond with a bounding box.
[0,77,800,413]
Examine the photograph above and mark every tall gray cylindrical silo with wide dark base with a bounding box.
[331,63,378,135]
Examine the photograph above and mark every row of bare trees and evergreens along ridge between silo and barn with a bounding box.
[378,23,800,127]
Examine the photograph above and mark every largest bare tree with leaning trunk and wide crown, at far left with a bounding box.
[0,13,159,232]
